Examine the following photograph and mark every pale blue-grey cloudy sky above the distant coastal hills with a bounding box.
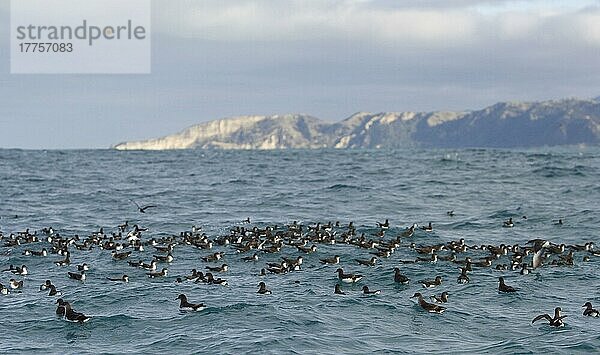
[0,0,600,149]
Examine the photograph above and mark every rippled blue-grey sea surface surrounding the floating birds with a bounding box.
[0,147,600,354]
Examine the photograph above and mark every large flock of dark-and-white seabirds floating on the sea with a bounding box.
[0,202,600,327]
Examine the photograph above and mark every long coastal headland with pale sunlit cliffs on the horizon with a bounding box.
[113,97,600,150]
